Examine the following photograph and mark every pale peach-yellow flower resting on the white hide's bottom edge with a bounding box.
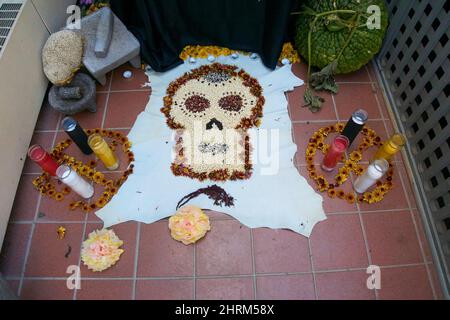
[169,205,211,245]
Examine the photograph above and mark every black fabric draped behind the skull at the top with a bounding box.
[111,0,296,72]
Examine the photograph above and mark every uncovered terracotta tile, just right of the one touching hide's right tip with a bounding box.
[363,211,423,266]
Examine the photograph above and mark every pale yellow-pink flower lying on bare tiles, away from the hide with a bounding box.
[81,229,124,272]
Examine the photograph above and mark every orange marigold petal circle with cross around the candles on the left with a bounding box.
[33,129,134,212]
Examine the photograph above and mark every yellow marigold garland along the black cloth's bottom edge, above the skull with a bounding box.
[180,42,300,63]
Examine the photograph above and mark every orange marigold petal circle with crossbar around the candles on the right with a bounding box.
[306,123,394,203]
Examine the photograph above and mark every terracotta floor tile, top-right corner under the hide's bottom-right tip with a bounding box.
[253,228,311,273]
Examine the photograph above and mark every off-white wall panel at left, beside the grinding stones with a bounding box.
[0,0,75,248]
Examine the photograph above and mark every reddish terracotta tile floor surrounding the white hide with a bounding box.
[0,64,442,299]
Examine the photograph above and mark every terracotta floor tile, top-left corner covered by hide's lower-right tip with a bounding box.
[310,214,368,270]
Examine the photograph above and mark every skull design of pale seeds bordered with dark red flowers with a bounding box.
[161,63,264,181]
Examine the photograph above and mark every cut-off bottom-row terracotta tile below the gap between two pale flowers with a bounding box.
[136,280,194,300]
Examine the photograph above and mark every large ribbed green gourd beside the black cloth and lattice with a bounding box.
[295,0,388,74]
